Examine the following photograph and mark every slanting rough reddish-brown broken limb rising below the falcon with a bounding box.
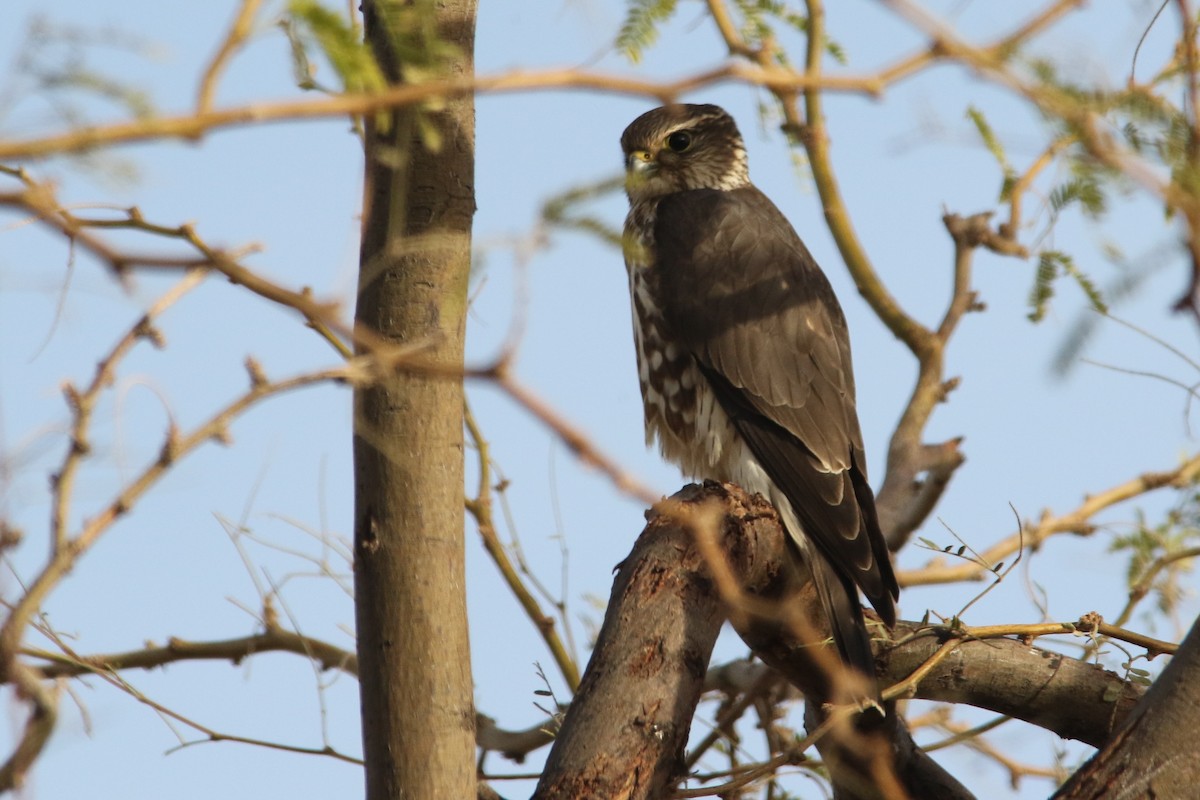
[533,487,736,800]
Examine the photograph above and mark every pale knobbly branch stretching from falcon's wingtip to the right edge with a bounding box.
[896,455,1200,587]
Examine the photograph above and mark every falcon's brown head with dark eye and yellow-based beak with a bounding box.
[620,104,750,203]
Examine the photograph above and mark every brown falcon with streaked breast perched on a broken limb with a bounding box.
[620,106,899,676]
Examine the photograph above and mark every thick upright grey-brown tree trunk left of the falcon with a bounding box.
[354,0,475,800]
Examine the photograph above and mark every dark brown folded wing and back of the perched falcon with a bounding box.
[654,187,899,625]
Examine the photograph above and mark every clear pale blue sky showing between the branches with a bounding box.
[0,0,1196,799]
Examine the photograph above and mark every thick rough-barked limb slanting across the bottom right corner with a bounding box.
[1054,609,1200,800]
